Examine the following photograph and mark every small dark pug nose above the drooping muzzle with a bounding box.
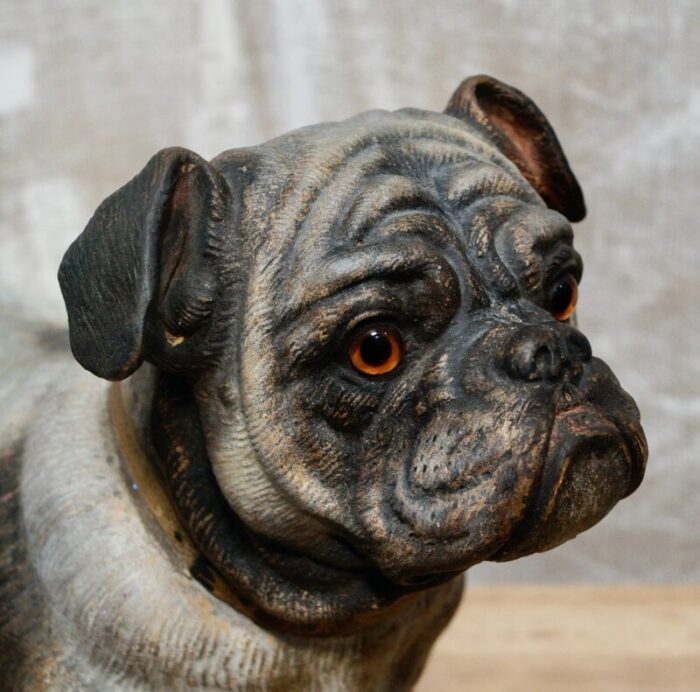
[506,324,591,382]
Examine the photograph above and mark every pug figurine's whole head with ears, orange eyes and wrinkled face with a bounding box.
[61,78,646,621]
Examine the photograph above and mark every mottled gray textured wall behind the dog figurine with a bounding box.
[0,0,700,581]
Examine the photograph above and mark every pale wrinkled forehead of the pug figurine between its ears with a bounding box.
[219,109,542,250]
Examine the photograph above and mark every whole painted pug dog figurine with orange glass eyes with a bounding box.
[0,76,647,691]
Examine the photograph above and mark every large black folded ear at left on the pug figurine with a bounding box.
[58,148,230,380]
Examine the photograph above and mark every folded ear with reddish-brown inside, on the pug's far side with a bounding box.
[445,75,586,221]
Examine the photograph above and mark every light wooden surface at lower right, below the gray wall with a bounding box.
[416,586,700,692]
